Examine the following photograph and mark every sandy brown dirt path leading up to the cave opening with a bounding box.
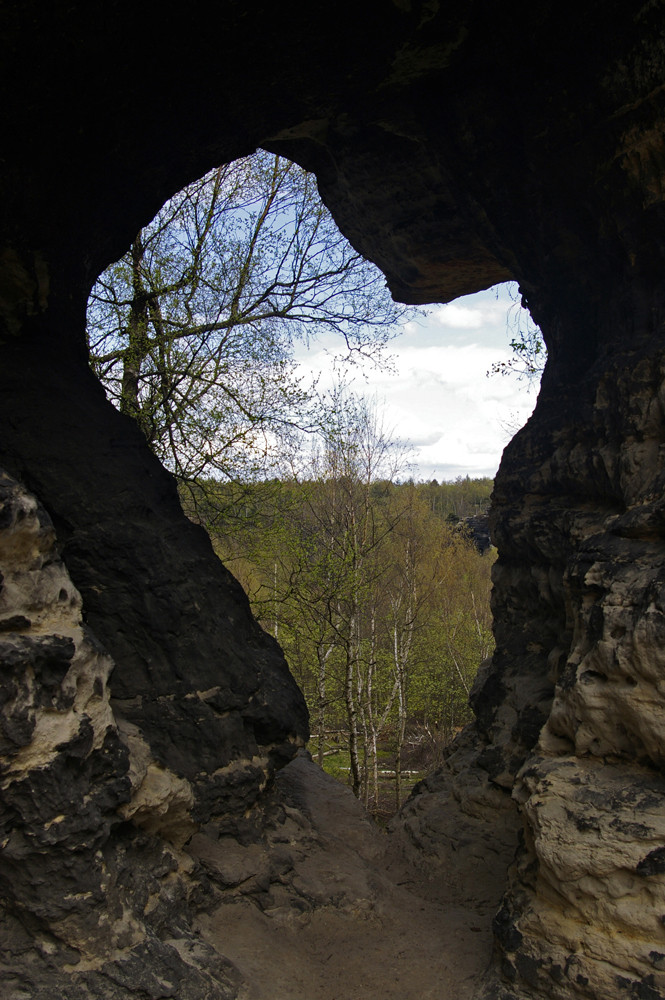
[199,760,506,1000]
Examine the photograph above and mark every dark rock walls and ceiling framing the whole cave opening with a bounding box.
[0,0,665,1000]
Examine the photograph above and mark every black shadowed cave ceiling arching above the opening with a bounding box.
[2,2,663,330]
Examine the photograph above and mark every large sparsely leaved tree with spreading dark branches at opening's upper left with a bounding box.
[88,151,406,481]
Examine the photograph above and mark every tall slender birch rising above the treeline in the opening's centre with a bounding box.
[280,391,404,800]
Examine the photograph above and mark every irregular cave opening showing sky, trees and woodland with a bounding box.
[80,150,543,821]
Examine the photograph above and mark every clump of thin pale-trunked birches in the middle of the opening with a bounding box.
[214,390,404,800]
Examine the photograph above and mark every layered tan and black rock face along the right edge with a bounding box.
[477,316,665,997]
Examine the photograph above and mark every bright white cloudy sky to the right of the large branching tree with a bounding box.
[296,285,538,482]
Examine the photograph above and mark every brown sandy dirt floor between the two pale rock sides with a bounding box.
[190,755,510,1000]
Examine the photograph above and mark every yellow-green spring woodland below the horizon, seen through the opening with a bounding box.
[202,460,493,820]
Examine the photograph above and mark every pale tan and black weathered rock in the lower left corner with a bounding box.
[0,473,245,1000]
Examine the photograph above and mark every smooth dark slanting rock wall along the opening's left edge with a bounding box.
[0,321,307,821]
